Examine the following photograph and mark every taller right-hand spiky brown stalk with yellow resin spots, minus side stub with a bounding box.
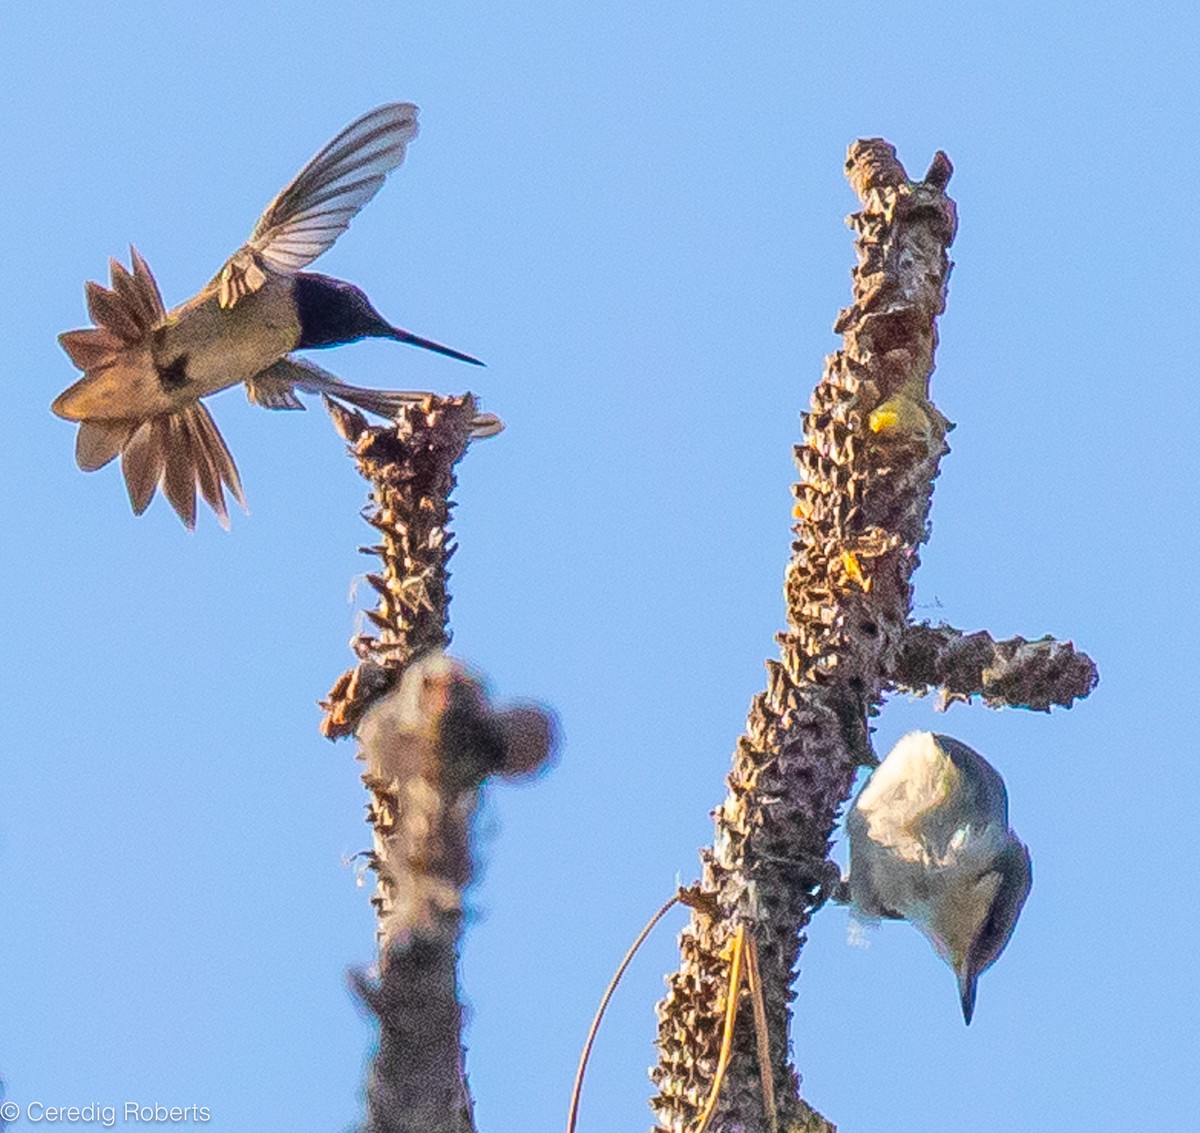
[652,138,1090,1133]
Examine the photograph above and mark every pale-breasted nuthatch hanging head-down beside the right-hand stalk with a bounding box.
[846,732,1032,1023]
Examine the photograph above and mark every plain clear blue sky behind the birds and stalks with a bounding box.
[0,0,1200,1133]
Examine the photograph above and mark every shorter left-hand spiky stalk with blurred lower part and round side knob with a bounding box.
[322,396,554,1133]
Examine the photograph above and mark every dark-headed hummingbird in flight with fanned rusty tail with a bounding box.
[50,102,503,528]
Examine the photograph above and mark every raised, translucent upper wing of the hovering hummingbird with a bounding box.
[214,102,416,307]
